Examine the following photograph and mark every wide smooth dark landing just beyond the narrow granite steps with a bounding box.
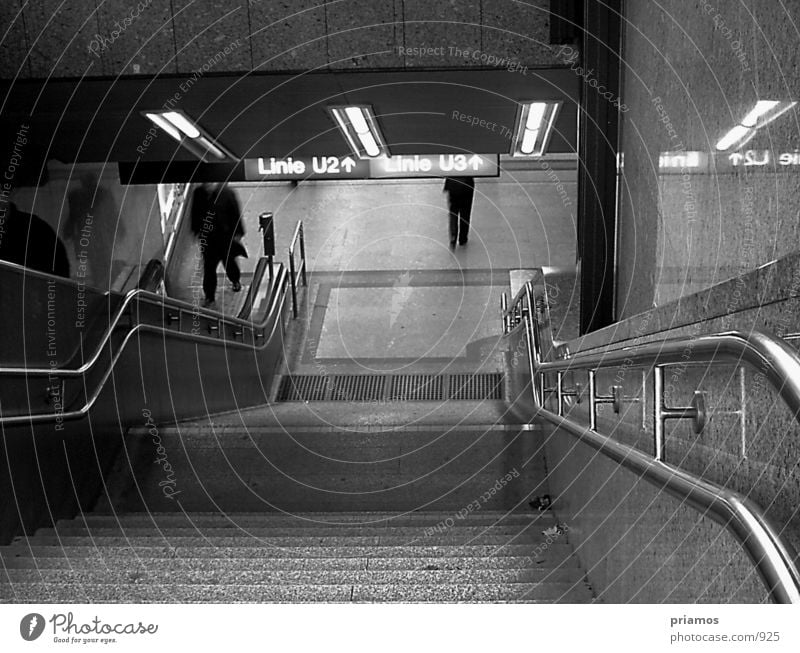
[99,428,546,512]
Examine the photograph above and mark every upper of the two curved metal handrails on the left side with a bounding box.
[0,260,284,377]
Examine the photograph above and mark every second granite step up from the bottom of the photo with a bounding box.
[0,564,576,587]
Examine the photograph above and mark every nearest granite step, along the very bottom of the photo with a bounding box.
[0,582,592,604]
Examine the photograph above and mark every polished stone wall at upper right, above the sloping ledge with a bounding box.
[617,0,800,318]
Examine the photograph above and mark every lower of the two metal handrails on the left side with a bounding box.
[0,268,286,426]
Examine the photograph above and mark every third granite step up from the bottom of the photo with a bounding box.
[0,542,572,565]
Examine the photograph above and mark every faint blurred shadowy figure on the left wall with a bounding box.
[64,172,125,290]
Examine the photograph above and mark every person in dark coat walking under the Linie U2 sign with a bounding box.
[191,184,247,306]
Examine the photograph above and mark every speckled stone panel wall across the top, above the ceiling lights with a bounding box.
[0,0,556,79]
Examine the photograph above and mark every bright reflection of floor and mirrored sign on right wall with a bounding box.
[654,139,800,305]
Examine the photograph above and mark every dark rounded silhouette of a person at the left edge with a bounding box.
[0,202,69,279]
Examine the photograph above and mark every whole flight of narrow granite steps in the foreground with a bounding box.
[0,511,592,603]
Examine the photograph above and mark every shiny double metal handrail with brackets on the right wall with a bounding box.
[501,282,800,603]
